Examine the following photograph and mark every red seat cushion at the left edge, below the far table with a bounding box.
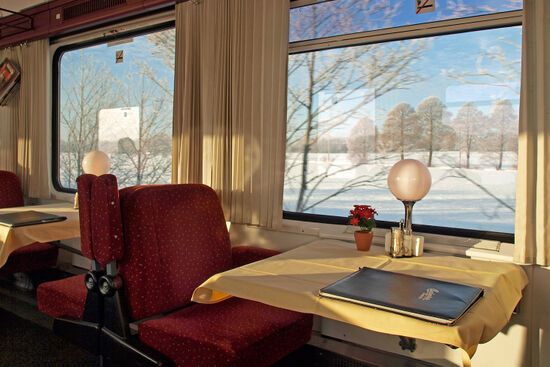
[0,242,59,276]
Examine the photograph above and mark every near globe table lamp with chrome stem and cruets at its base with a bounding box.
[387,159,432,257]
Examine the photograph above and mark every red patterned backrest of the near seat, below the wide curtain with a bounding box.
[119,184,232,320]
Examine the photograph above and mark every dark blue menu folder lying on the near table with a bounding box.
[319,268,483,325]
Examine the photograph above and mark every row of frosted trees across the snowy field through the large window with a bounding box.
[287,97,518,169]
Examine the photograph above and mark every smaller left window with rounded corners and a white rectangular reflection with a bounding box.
[53,24,175,192]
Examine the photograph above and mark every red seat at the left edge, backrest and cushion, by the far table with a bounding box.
[0,171,59,276]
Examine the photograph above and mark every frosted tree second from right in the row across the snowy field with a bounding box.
[453,102,487,168]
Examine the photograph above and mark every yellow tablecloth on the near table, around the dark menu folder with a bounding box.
[192,240,528,365]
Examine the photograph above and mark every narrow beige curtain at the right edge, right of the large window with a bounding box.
[514,0,550,266]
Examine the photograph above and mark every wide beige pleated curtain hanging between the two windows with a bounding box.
[173,0,289,228]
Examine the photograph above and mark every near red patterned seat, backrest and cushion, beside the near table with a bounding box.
[112,184,312,367]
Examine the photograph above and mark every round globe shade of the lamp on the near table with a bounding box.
[388,159,432,201]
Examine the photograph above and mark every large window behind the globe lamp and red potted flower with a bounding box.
[283,0,521,240]
